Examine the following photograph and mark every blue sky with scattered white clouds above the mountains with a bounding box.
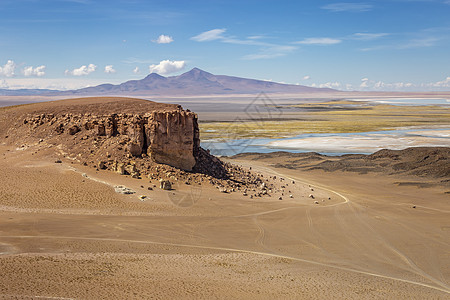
[0,0,450,91]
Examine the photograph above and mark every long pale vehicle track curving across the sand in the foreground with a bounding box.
[0,235,450,294]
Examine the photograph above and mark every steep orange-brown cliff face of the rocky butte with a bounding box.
[19,107,200,171]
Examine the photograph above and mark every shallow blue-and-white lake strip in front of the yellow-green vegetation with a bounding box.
[201,127,450,156]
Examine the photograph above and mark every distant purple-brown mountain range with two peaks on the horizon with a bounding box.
[0,68,335,96]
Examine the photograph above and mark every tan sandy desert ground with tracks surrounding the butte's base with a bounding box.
[0,146,450,299]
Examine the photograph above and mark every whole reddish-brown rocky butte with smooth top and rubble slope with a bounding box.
[0,97,232,178]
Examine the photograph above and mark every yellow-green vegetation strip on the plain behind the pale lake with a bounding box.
[199,103,450,140]
